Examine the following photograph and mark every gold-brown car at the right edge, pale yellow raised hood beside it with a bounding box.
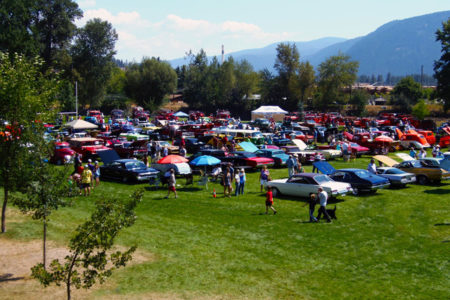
[373,155,450,185]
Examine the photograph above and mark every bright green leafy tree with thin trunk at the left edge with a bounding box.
[0,52,59,232]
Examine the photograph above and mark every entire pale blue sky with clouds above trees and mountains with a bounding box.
[76,0,450,62]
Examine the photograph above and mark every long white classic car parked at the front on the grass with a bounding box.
[266,173,352,197]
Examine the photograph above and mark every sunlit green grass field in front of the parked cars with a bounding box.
[0,157,450,299]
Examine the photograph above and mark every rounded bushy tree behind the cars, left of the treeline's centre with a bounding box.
[125,57,177,110]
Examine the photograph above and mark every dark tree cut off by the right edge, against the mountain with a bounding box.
[434,19,450,111]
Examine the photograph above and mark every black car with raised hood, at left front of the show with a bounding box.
[99,150,159,182]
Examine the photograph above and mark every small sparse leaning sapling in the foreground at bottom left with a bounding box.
[31,190,144,300]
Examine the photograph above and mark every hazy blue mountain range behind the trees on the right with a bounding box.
[169,11,450,76]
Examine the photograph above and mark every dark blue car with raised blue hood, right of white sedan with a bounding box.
[313,161,390,195]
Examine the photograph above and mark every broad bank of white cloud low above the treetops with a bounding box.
[77,8,290,61]
